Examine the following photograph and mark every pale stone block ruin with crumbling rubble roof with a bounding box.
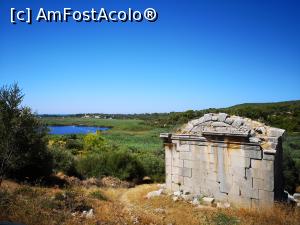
[160,113,285,207]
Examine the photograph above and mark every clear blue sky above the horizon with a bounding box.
[0,0,300,113]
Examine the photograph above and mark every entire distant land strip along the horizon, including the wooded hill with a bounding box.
[39,100,300,132]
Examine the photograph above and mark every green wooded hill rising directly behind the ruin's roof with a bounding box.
[145,100,300,132]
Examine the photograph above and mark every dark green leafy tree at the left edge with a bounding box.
[0,84,52,185]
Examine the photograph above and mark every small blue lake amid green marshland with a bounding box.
[48,126,110,135]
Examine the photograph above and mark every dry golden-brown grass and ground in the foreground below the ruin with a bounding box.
[0,181,300,225]
